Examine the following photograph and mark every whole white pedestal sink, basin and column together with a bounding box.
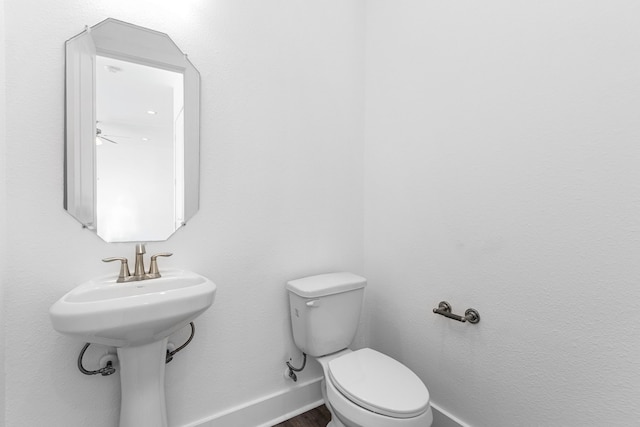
[49,270,216,427]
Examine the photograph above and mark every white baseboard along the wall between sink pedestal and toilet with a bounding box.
[184,377,324,427]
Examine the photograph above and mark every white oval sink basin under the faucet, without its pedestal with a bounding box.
[49,270,216,347]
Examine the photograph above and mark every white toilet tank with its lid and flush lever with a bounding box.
[286,273,367,357]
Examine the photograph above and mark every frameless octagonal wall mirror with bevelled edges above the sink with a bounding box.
[64,18,200,242]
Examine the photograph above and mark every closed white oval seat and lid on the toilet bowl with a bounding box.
[328,348,429,418]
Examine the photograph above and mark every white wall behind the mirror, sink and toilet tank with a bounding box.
[0,0,364,427]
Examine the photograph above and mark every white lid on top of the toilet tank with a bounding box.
[286,272,367,298]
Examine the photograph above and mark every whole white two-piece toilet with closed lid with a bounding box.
[286,272,433,427]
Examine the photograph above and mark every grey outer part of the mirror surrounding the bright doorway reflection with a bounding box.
[64,18,200,242]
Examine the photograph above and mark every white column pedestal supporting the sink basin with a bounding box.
[117,338,168,427]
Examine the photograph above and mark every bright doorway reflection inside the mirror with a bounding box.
[96,55,184,242]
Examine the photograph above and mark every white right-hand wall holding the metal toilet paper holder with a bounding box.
[365,0,640,427]
